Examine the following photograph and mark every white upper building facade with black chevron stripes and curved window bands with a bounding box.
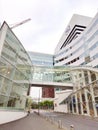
[54,14,98,67]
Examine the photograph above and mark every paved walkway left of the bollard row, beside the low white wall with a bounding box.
[0,113,61,130]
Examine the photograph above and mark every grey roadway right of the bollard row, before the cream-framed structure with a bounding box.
[40,111,98,130]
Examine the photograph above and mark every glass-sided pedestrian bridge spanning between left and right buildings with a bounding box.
[30,66,73,89]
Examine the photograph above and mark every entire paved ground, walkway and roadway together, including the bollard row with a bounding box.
[0,110,98,130]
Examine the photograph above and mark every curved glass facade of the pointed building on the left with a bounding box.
[0,23,32,109]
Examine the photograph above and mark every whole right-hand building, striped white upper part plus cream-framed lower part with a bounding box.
[54,13,98,117]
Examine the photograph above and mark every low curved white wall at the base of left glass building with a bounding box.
[0,110,27,124]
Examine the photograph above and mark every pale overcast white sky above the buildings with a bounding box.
[0,0,98,97]
